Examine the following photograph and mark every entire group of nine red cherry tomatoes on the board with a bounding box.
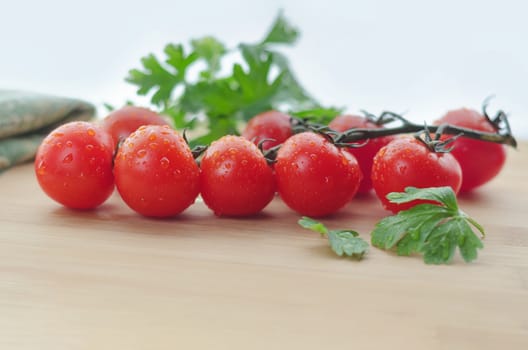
[35,106,505,217]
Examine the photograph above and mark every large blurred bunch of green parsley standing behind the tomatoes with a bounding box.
[126,13,340,144]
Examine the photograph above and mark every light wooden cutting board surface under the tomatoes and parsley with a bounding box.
[0,143,528,350]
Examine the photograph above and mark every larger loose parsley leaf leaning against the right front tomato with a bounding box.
[371,187,484,264]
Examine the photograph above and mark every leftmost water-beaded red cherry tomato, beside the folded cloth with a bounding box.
[35,122,114,209]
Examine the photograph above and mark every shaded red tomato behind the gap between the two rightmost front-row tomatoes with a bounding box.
[328,115,394,194]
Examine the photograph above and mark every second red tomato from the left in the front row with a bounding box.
[114,125,200,217]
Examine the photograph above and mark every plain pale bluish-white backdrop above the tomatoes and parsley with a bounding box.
[0,0,528,139]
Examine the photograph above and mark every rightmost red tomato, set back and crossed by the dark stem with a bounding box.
[435,108,506,192]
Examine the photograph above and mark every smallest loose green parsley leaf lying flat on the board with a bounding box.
[298,216,369,259]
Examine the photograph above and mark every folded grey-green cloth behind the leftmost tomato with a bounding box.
[0,89,95,171]
